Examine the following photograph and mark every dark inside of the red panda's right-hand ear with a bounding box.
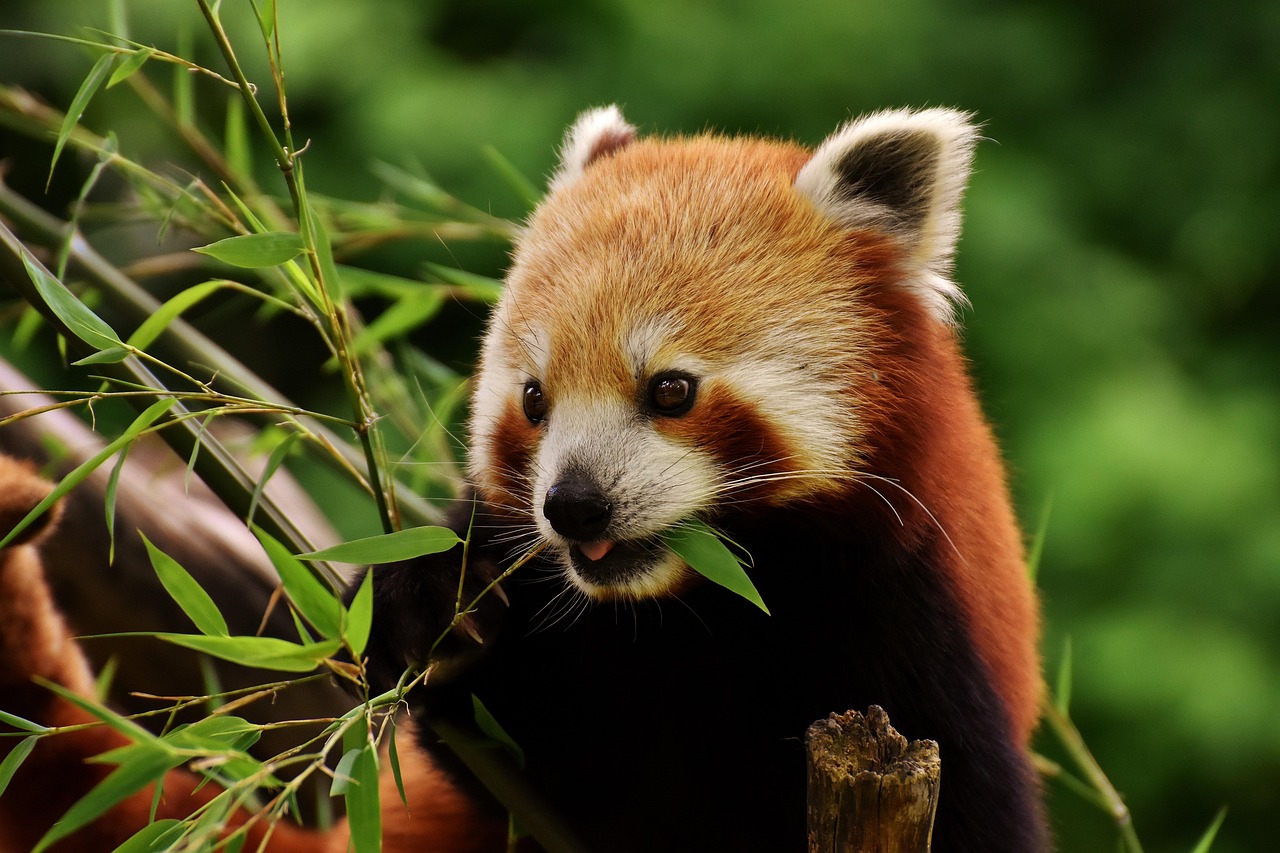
[836,131,938,228]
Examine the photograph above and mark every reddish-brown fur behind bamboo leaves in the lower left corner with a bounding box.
[0,456,491,853]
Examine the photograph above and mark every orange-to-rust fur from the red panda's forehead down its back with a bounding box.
[480,137,1041,743]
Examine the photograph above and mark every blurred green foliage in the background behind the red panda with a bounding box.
[0,0,1280,853]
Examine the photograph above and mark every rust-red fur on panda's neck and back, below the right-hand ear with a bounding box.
[839,263,1042,743]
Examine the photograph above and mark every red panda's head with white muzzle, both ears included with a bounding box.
[471,108,975,598]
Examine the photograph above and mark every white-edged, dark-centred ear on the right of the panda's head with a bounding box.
[795,109,978,320]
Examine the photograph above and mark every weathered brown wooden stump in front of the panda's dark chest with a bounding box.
[805,704,942,853]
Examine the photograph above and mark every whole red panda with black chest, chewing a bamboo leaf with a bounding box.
[0,108,1048,853]
